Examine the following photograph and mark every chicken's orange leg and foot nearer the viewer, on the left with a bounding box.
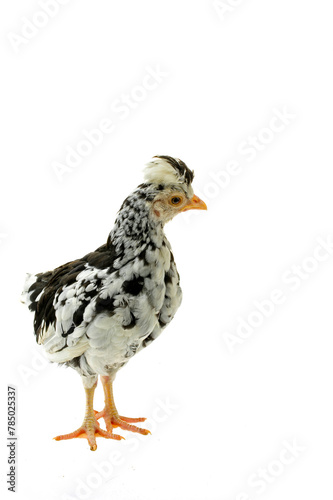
[54,382,124,451]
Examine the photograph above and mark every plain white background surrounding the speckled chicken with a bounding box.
[0,0,333,500]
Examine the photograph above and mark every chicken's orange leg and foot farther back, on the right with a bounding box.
[95,375,150,435]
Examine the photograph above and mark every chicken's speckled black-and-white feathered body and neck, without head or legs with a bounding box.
[27,189,182,387]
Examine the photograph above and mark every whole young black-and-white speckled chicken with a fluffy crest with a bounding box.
[22,156,207,451]
